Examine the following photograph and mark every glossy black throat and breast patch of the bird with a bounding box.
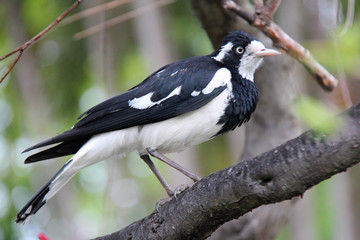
[216,73,258,135]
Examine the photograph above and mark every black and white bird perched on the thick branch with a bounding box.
[15,30,281,224]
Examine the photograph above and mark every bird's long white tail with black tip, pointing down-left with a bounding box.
[15,159,79,224]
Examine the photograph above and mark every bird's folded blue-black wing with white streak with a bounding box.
[25,56,226,156]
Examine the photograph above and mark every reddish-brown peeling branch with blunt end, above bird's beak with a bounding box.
[222,0,338,91]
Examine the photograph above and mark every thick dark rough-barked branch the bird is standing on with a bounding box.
[97,103,360,240]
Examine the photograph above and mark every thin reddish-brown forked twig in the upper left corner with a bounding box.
[0,0,83,84]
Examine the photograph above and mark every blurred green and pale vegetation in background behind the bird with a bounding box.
[0,0,360,240]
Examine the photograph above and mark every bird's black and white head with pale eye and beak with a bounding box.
[211,31,281,81]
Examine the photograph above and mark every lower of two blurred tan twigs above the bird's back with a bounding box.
[74,0,175,40]
